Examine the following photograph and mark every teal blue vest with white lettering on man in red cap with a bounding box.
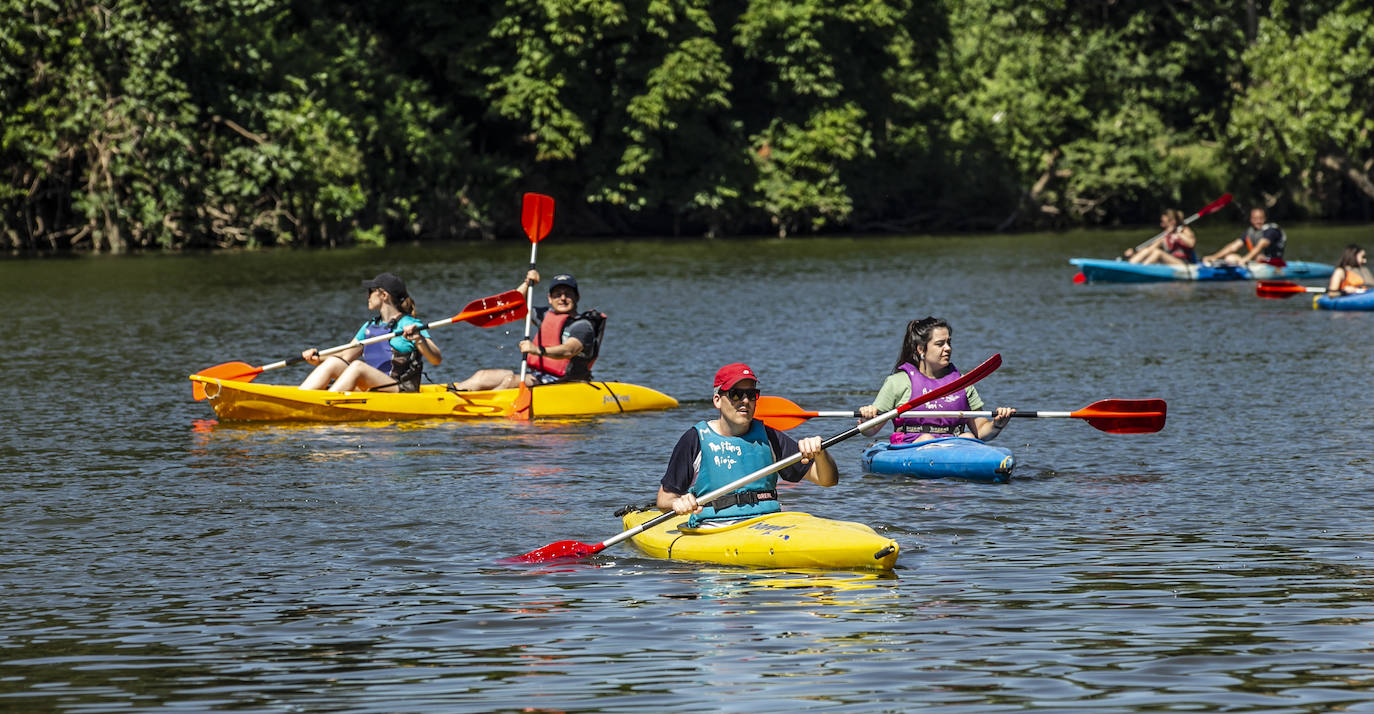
[687,419,782,527]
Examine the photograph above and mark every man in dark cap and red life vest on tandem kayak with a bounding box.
[453,270,598,391]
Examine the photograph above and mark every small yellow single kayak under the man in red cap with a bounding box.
[622,511,900,570]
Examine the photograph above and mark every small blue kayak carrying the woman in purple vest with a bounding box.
[861,437,1015,483]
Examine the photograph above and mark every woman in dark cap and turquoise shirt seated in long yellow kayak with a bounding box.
[301,273,444,391]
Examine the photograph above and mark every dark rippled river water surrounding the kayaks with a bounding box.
[0,220,1374,713]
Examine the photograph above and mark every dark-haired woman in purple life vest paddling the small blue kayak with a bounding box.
[859,317,1015,444]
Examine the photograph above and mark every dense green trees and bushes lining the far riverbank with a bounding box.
[0,0,1374,251]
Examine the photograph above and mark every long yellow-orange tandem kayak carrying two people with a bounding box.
[191,375,677,422]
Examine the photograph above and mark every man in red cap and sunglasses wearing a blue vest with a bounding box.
[657,362,840,527]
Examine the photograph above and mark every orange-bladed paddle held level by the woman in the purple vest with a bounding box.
[754,397,1168,434]
